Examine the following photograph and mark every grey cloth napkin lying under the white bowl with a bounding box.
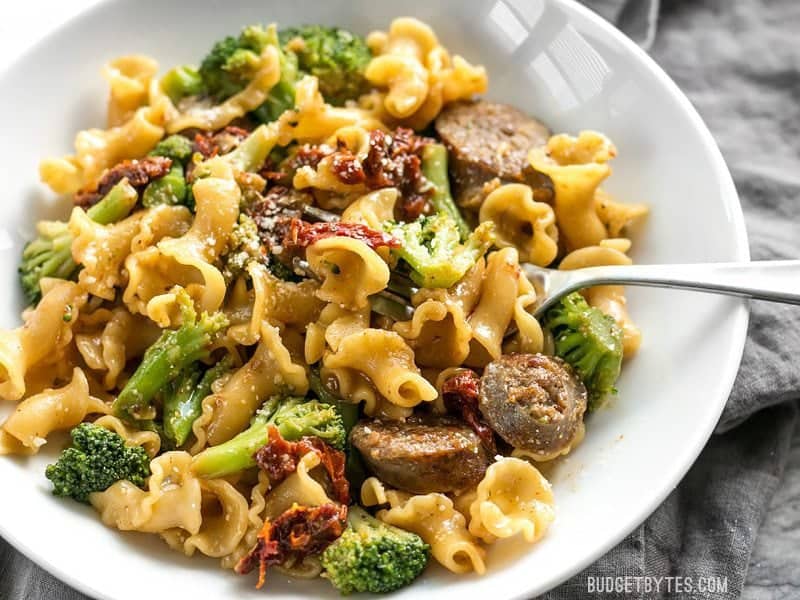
[0,0,800,600]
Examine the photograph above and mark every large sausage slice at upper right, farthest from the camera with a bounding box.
[436,100,553,210]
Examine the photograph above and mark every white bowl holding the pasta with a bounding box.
[0,0,748,600]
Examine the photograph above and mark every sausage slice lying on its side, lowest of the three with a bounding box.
[350,417,490,494]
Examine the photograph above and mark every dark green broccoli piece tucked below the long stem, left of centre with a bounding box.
[164,356,233,447]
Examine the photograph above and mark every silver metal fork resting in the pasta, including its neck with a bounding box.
[521,260,800,317]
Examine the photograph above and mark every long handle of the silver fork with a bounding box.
[570,260,800,304]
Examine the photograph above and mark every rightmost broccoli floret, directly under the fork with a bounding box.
[544,292,622,410]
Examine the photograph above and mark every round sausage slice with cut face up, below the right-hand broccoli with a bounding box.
[479,354,586,456]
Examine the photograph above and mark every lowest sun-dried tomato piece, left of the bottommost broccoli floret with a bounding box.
[235,502,347,589]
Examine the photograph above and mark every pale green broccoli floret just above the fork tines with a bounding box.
[384,214,494,288]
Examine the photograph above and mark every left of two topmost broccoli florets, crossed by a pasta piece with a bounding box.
[198,25,297,123]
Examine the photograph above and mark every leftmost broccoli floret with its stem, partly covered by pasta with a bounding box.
[19,179,138,305]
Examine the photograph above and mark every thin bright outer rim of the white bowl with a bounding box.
[0,0,750,600]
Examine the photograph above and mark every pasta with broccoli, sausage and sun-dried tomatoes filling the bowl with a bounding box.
[0,18,647,594]
